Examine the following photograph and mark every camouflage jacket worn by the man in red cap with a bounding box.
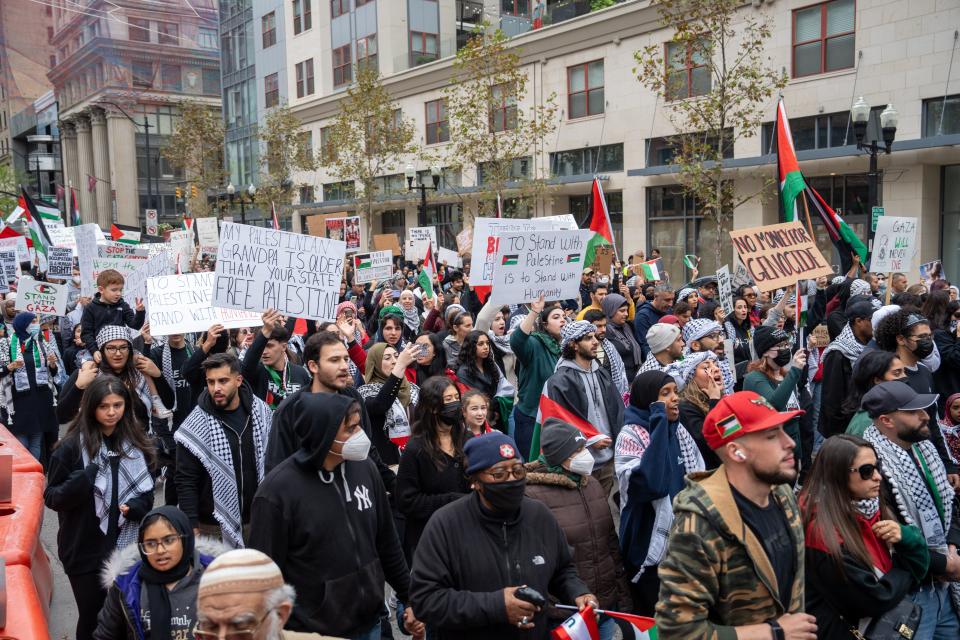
[657,466,804,640]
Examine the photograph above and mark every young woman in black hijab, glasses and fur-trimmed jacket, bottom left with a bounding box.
[93,505,227,640]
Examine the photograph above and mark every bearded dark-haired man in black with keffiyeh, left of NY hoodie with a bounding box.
[173,353,272,547]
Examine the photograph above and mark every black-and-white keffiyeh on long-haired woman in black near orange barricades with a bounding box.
[80,436,154,549]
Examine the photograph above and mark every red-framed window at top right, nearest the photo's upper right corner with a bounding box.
[793,0,856,78]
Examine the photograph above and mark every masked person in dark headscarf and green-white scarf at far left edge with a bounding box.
[0,311,61,460]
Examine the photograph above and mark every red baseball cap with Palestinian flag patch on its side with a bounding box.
[703,391,804,450]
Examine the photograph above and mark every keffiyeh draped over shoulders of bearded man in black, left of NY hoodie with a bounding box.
[173,397,273,549]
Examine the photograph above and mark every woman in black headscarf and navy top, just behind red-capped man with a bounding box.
[614,371,706,616]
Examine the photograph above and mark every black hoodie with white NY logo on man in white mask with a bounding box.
[249,393,410,637]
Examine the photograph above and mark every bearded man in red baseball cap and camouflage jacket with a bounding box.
[657,391,817,640]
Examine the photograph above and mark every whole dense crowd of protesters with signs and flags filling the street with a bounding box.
[0,110,960,640]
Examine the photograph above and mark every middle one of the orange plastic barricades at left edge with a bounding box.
[0,473,53,612]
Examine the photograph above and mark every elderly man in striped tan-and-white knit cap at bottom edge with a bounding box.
[193,549,344,640]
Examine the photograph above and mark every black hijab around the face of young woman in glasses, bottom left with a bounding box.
[137,506,195,638]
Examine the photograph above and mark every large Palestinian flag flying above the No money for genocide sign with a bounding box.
[777,98,867,272]
